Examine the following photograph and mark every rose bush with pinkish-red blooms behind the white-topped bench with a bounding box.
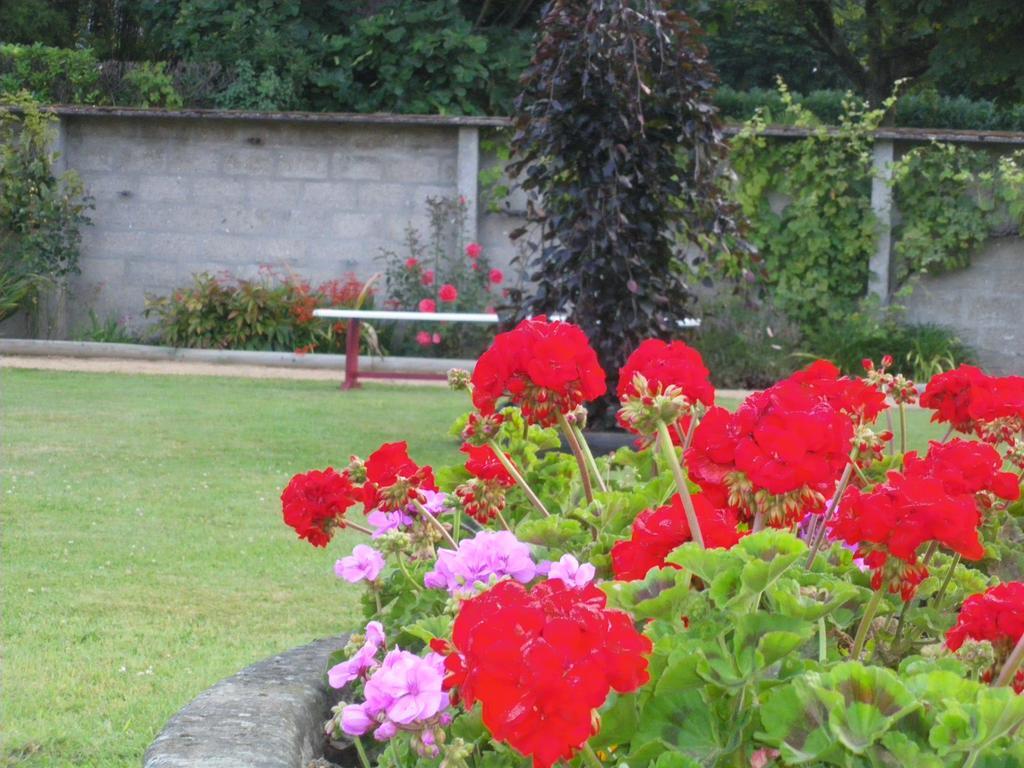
[380,198,506,357]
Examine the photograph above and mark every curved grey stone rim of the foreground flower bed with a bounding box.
[142,636,347,768]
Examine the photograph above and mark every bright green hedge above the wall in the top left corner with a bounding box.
[0,43,99,104]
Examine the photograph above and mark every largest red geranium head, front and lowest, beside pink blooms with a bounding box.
[445,579,651,768]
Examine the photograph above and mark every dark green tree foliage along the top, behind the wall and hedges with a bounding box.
[0,0,1024,114]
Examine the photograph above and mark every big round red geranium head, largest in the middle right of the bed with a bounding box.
[686,378,853,527]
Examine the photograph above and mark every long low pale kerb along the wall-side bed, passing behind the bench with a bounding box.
[0,339,475,376]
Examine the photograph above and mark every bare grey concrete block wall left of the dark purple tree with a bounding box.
[54,115,520,333]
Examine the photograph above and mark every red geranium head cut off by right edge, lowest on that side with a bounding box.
[946,582,1024,693]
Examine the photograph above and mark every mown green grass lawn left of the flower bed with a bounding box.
[0,370,941,768]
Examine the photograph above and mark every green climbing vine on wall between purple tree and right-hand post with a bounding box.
[729,86,884,326]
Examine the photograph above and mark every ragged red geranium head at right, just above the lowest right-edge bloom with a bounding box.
[831,472,985,600]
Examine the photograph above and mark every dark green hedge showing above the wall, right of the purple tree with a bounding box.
[715,86,1024,131]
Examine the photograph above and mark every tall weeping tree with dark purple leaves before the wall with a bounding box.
[510,0,735,421]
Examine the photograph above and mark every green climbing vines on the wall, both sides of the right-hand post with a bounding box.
[723,86,1024,329]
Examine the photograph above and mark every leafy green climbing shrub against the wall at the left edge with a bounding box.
[0,93,91,319]
